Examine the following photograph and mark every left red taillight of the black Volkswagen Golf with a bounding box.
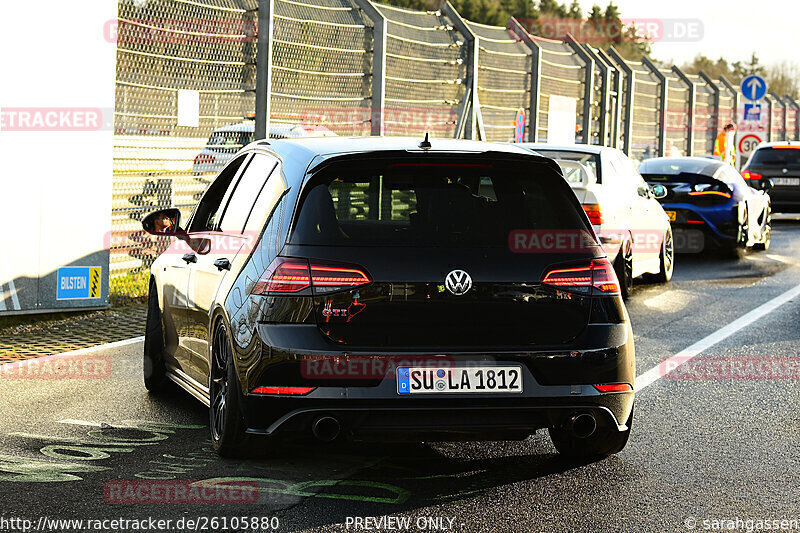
[253,257,372,294]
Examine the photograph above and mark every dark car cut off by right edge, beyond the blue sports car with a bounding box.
[742,142,800,213]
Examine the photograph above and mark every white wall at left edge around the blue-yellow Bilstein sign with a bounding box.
[0,0,117,313]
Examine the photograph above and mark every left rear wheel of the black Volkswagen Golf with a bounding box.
[209,322,246,457]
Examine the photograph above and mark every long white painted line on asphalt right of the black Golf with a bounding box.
[636,285,800,391]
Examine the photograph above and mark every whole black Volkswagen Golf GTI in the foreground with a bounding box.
[143,138,634,456]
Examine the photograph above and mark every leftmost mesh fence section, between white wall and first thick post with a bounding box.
[109,0,257,298]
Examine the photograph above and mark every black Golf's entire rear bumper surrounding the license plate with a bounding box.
[234,323,635,441]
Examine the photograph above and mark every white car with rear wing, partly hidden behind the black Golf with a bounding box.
[522,143,675,297]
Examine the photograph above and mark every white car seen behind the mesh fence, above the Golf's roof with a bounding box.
[192,120,336,174]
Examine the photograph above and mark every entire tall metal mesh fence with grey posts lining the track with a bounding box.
[109,0,800,301]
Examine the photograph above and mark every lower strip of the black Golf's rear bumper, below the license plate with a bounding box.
[241,391,634,441]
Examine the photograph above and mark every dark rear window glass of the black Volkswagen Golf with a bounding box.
[290,160,586,247]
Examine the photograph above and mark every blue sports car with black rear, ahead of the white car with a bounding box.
[639,157,771,253]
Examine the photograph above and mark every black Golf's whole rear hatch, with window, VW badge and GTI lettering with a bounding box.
[274,154,603,350]
